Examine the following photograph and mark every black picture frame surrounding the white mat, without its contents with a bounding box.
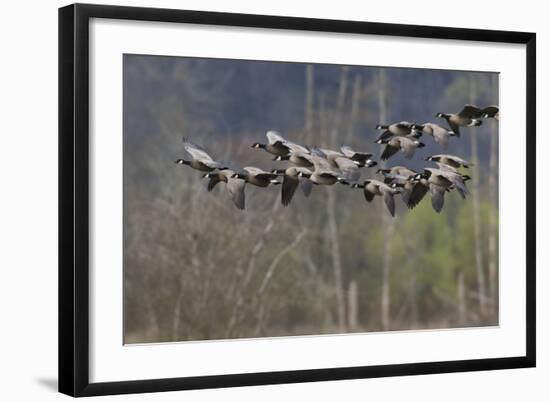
[59,4,536,396]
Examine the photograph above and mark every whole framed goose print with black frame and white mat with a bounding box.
[59,4,536,396]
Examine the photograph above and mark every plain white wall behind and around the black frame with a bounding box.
[0,0,550,401]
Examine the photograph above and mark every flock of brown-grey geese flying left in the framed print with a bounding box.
[176,104,499,216]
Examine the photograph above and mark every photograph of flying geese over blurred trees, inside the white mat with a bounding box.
[122,54,500,344]
